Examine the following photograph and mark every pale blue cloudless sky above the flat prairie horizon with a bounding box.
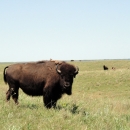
[0,0,130,62]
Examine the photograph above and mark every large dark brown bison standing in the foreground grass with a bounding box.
[3,60,79,108]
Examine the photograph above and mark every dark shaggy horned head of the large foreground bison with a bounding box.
[56,63,79,95]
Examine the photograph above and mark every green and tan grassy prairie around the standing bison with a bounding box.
[0,60,130,130]
